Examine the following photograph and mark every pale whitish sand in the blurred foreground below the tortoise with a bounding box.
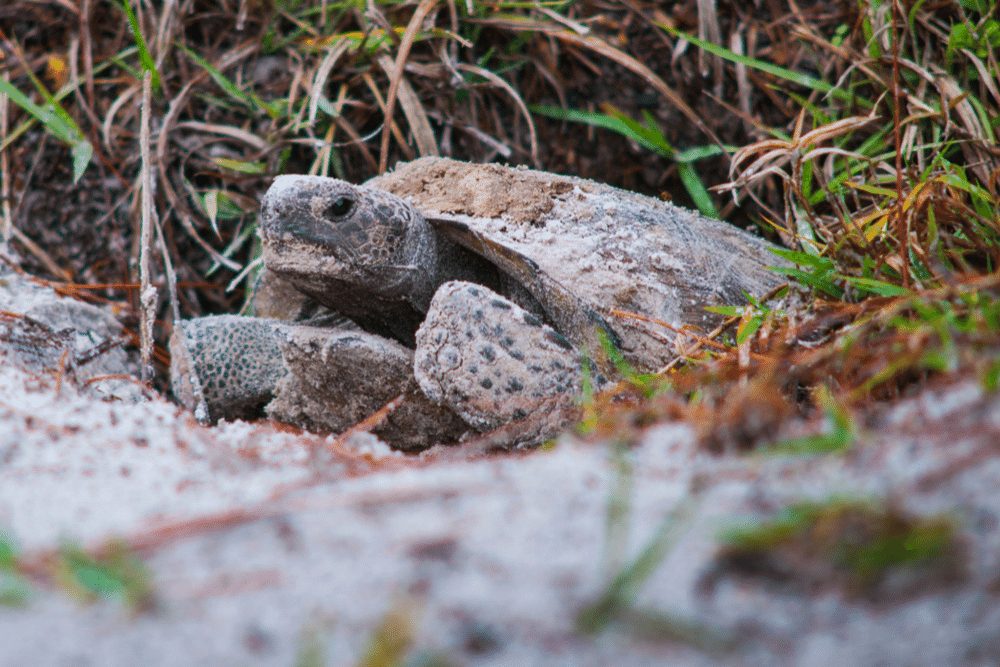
[0,264,1000,665]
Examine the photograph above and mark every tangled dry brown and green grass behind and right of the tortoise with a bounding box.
[0,0,1000,456]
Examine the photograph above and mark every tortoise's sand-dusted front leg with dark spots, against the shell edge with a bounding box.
[414,281,582,444]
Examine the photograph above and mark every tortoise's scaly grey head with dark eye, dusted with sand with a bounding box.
[261,176,436,308]
